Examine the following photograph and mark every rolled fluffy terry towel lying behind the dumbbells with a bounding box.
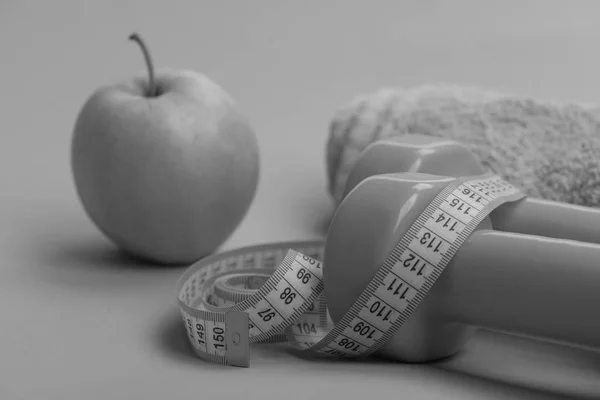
[326,86,600,207]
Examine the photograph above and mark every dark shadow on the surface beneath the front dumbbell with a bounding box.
[278,330,600,400]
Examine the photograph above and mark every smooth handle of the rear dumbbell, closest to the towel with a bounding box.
[490,197,600,243]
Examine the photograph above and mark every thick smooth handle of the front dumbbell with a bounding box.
[447,228,600,348]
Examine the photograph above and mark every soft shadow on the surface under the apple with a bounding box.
[28,213,189,295]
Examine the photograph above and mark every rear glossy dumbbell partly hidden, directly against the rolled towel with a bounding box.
[343,134,600,243]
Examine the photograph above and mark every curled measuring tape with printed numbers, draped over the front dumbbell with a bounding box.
[177,174,525,367]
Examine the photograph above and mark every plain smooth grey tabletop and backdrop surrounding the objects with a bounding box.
[0,0,600,400]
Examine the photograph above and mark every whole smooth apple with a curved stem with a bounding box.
[71,33,260,264]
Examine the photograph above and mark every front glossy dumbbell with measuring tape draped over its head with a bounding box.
[323,172,600,362]
